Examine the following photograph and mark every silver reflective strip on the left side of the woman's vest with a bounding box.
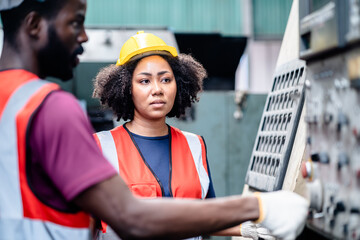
[96,131,119,172]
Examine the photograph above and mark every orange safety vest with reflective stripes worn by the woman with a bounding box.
[95,126,210,199]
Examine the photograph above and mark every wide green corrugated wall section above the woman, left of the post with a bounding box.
[86,0,243,36]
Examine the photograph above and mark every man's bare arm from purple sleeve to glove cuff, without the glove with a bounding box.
[74,175,259,239]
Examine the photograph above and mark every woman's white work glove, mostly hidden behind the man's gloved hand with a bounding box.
[240,221,275,240]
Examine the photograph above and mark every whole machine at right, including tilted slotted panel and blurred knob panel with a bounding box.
[245,0,360,240]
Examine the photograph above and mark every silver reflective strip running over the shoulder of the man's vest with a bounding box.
[0,80,47,218]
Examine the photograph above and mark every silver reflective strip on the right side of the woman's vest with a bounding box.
[181,131,210,199]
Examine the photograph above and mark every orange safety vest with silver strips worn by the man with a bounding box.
[0,70,90,239]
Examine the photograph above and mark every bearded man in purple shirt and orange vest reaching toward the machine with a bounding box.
[0,0,308,239]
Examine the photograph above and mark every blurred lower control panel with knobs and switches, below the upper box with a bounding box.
[302,47,360,240]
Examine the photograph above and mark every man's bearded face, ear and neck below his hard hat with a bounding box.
[0,0,88,80]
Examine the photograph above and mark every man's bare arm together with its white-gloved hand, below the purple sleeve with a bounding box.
[74,175,307,239]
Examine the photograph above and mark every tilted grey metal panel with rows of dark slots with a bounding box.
[246,60,305,191]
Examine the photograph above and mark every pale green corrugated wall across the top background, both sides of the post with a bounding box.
[86,0,292,39]
